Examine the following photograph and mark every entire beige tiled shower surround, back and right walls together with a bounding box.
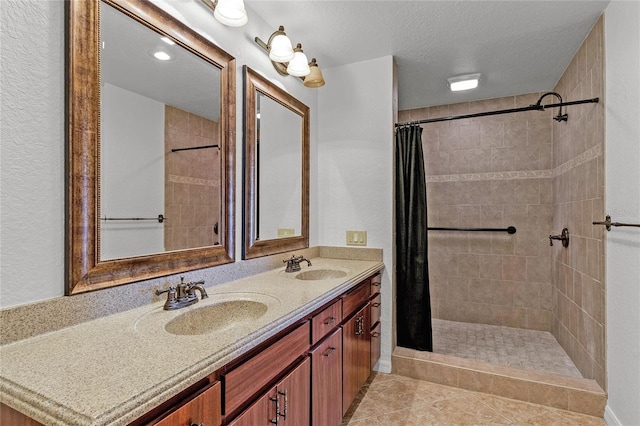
[398,18,606,389]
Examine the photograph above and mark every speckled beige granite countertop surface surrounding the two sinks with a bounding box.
[0,258,383,425]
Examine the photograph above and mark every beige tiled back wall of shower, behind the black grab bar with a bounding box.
[399,93,553,331]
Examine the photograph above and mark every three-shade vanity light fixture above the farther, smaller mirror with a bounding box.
[255,25,324,87]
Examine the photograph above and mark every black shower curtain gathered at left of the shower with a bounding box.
[396,124,433,352]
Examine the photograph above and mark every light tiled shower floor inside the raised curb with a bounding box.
[432,319,582,378]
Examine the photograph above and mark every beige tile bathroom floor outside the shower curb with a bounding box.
[342,373,606,426]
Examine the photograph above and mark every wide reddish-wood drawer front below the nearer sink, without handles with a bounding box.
[223,321,311,414]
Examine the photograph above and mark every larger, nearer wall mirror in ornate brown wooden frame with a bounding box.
[66,0,235,295]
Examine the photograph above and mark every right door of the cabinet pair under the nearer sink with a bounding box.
[276,357,311,426]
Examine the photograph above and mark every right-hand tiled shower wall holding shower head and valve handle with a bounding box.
[552,17,606,389]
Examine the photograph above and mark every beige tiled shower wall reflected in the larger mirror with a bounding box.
[164,105,221,250]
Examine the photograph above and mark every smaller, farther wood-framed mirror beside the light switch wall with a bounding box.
[243,66,309,259]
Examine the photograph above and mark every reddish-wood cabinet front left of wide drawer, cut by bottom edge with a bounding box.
[155,382,222,426]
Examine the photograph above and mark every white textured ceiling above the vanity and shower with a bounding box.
[245,0,608,109]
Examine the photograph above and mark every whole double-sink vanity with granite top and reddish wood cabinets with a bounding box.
[0,258,383,426]
